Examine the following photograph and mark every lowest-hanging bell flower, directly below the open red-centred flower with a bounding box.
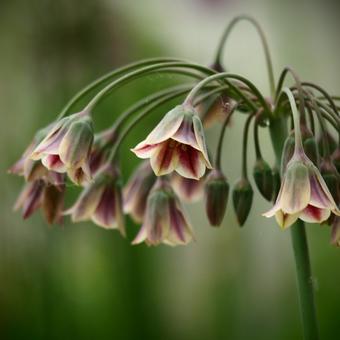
[132,178,193,246]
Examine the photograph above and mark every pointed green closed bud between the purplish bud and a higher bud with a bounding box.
[233,178,253,227]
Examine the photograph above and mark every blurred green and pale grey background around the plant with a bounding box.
[0,0,340,340]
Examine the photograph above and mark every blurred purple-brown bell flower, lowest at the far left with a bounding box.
[14,178,65,224]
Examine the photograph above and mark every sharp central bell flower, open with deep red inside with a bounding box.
[132,105,212,179]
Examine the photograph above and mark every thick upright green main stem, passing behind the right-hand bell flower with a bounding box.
[270,99,318,340]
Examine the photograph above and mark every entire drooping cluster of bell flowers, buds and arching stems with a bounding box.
[10,19,340,246]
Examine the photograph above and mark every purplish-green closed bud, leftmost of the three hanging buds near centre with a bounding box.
[205,169,229,227]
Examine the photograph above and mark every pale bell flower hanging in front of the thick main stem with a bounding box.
[263,150,340,228]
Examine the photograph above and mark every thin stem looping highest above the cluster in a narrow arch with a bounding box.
[215,15,275,96]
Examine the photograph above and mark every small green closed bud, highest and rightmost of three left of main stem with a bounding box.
[253,158,274,201]
